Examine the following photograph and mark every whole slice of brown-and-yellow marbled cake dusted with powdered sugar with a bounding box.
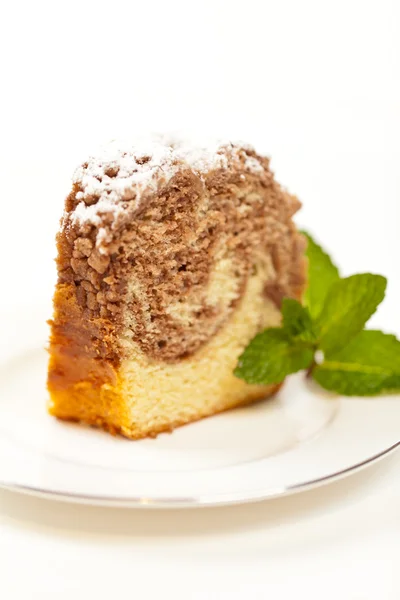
[48,136,305,439]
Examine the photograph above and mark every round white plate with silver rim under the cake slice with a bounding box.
[0,314,400,507]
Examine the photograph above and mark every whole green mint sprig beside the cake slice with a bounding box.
[235,234,400,396]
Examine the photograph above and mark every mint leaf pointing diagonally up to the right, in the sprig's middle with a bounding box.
[316,273,387,355]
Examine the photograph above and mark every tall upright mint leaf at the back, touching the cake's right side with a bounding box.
[302,231,340,319]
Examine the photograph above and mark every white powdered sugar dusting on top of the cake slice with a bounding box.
[69,135,263,251]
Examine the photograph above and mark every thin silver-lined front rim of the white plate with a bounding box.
[0,439,400,510]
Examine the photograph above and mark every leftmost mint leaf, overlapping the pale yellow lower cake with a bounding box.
[234,328,314,385]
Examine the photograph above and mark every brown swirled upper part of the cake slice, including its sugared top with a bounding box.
[57,136,304,364]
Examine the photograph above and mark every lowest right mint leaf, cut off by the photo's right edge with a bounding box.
[313,330,400,396]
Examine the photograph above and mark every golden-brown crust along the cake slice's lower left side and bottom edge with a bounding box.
[48,285,281,439]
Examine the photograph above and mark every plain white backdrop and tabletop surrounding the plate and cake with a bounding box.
[0,0,400,600]
